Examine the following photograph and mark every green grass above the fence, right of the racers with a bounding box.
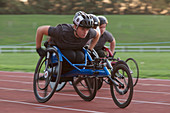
[107,15,170,45]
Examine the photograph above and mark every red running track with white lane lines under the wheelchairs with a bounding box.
[0,71,170,113]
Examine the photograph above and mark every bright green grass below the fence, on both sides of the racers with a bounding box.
[0,52,170,79]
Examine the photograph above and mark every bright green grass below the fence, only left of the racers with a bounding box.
[0,53,39,72]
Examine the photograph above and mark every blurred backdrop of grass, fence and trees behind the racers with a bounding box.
[0,0,170,79]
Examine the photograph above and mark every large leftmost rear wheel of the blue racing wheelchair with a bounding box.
[33,47,62,103]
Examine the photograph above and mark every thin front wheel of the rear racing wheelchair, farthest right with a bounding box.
[126,58,139,86]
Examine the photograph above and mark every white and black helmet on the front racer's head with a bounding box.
[73,11,94,28]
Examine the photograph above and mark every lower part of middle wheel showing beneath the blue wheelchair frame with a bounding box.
[73,76,97,101]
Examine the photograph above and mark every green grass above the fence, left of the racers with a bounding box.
[0,15,72,45]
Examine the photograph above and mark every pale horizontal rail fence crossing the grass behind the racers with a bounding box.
[0,46,170,53]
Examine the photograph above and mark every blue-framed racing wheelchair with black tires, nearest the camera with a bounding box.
[33,46,133,108]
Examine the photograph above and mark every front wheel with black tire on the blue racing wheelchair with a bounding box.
[110,64,133,108]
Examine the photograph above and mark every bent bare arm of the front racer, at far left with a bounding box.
[36,26,50,49]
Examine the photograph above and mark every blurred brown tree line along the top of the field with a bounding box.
[0,0,170,15]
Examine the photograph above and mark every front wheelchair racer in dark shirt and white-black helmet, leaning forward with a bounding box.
[36,11,99,74]
